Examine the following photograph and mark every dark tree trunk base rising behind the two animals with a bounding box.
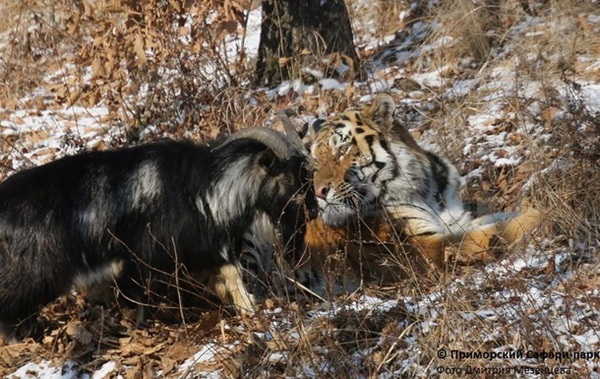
[256,0,362,86]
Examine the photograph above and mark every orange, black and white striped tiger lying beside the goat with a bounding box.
[306,93,541,270]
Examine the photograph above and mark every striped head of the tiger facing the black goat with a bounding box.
[311,94,416,226]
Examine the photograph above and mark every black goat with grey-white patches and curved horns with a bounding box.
[0,128,318,339]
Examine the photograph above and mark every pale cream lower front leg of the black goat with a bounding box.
[213,263,254,314]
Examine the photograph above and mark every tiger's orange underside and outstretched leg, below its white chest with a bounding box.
[306,209,541,282]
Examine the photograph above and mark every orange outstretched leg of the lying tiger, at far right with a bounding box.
[412,209,542,268]
